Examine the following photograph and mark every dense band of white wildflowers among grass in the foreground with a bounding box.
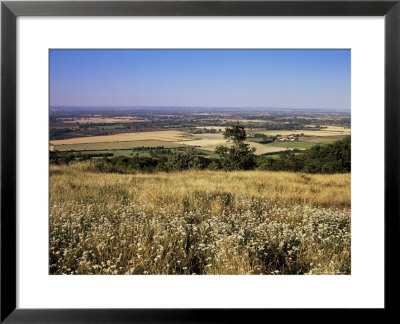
[49,192,351,275]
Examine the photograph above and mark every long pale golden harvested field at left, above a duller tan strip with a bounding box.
[50,131,189,145]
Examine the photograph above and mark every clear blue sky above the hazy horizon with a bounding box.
[50,50,351,109]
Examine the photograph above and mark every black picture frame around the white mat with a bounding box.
[0,0,400,323]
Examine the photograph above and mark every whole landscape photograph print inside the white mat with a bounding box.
[49,49,351,275]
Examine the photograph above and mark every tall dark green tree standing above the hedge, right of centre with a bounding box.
[215,123,256,170]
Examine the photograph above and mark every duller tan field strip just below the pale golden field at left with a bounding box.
[54,140,185,151]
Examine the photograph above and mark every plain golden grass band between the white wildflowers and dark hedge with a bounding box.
[50,163,351,207]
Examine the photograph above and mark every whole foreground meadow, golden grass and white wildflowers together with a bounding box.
[49,163,350,274]
